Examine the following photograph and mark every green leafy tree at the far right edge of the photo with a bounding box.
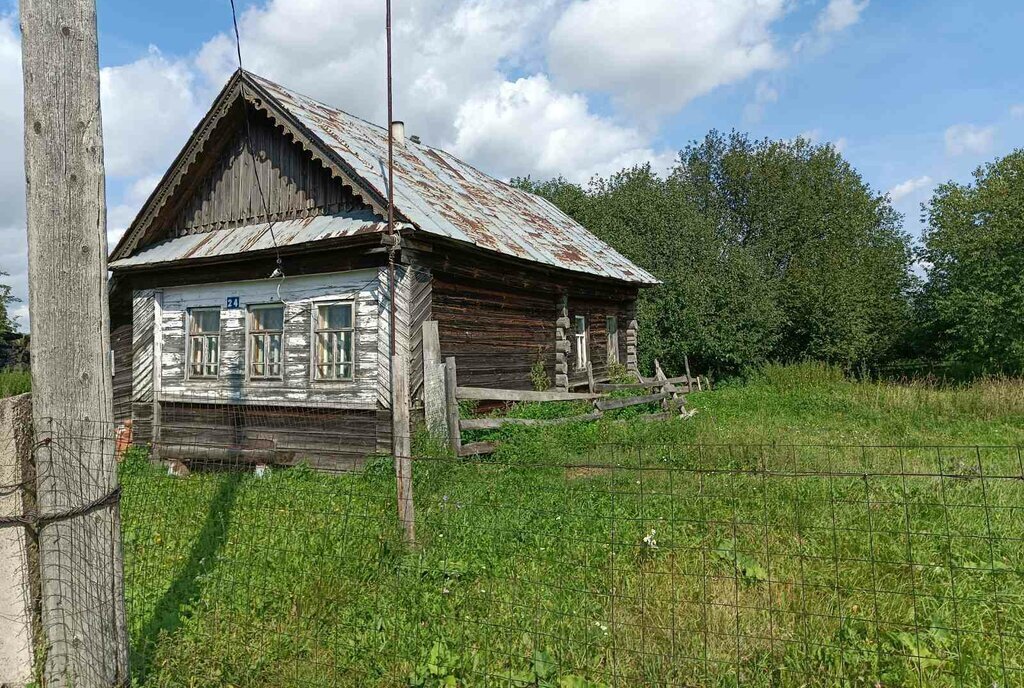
[922,149,1024,373]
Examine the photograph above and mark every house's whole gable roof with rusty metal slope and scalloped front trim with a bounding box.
[112,72,658,285]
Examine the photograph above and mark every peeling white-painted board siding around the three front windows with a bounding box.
[159,270,380,410]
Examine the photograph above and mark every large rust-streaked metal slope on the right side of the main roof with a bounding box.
[251,74,658,285]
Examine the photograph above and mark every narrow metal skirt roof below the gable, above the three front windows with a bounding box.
[110,213,400,268]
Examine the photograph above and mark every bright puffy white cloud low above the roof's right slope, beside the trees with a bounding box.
[453,75,672,181]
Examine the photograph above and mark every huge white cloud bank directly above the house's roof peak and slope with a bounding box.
[198,0,671,180]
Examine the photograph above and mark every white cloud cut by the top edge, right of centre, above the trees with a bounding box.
[548,0,791,116]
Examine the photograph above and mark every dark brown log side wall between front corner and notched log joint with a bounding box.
[433,271,557,389]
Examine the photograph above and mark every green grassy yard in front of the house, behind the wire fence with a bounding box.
[122,369,1024,687]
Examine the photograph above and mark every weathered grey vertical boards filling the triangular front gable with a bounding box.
[160,103,362,237]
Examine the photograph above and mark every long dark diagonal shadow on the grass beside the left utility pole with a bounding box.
[131,473,242,683]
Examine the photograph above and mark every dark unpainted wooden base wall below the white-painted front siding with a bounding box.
[159,402,382,471]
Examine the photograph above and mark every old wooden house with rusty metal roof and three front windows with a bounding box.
[110,72,657,468]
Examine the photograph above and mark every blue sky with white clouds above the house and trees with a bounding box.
[0,0,1024,325]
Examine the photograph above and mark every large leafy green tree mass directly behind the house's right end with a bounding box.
[515,131,913,370]
